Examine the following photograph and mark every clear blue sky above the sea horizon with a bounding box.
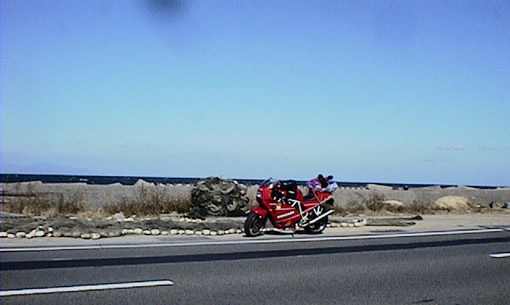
[0,0,510,186]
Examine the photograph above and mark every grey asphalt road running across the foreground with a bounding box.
[0,229,510,305]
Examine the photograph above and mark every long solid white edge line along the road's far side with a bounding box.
[0,229,503,252]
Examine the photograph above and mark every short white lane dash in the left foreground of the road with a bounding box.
[0,280,174,297]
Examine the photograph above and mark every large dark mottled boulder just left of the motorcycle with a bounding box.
[191,177,249,217]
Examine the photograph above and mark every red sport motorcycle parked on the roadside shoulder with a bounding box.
[244,178,336,236]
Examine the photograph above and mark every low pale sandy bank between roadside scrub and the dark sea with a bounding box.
[0,180,510,210]
